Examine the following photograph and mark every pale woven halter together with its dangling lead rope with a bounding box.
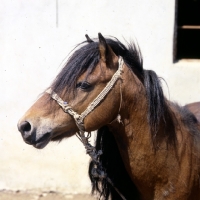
[46,57,126,200]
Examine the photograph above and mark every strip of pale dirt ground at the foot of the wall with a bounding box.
[0,190,97,200]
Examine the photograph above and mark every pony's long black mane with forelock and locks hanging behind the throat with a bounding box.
[51,38,176,200]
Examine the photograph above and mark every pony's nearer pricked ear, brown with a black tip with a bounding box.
[98,33,117,63]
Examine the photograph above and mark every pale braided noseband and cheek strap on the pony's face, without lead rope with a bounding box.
[46,57,124,132]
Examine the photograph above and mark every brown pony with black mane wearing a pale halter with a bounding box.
[18,33,200,200]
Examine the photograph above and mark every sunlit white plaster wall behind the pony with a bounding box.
[0,0,200,193]
